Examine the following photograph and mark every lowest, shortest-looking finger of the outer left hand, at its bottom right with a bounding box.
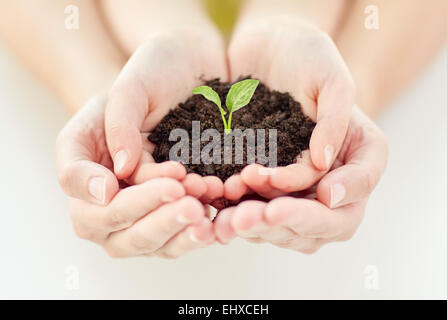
[155,218,214,259]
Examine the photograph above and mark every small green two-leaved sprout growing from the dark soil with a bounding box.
[192,79,259,134]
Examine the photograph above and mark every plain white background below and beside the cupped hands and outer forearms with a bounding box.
[0,40,447,299]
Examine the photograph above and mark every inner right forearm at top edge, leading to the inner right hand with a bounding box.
[234,0,349,37]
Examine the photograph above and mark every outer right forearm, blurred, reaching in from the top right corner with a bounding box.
[337,0,447,115]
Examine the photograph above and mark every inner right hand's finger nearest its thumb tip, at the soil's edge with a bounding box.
[270,151,324,192]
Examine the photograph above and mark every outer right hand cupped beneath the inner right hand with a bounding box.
[214,108,388,253]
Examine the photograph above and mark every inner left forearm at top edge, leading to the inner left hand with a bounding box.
[102,0,221,54]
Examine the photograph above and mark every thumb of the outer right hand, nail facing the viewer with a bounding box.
[317,119,388,208]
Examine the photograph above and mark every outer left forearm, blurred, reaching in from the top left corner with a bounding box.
[0,0,124,111]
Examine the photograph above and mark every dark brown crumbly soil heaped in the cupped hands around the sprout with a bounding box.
[148,79,315,181]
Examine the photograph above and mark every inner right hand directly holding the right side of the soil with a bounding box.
[225,18,355,200]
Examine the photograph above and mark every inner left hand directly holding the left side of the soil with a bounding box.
[105,28,227,202]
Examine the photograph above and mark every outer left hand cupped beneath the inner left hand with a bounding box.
[56,95,214,258]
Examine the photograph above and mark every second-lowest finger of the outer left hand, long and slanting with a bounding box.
[106,197,205,257]
